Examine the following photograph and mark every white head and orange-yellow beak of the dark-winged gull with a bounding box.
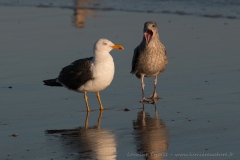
[93,38,124,53]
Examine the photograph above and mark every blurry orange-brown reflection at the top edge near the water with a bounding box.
[73,0,96,28]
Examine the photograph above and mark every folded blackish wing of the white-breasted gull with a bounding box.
[58,57,93,90]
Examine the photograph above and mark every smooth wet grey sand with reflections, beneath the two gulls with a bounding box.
[0,7,240,160]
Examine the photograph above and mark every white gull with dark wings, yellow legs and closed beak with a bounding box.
[43,39,124,112]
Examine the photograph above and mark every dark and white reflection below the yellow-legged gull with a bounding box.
[46,111,117,160]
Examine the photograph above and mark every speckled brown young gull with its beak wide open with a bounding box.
[131,21,168,103]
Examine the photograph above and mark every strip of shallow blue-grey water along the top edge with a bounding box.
[0,0,240,19]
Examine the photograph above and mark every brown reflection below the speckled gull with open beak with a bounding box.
[133,103,169,160]
